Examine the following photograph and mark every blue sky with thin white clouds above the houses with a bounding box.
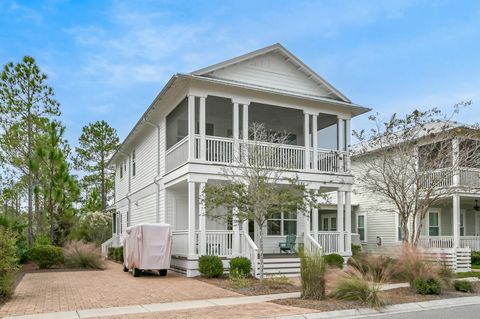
[0,0,480,145]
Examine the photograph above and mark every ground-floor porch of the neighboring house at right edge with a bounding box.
[418,194,480,251]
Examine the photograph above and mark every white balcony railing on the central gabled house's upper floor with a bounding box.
[165,135,350,173]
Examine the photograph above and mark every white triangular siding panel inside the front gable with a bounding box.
[212,52,328,96]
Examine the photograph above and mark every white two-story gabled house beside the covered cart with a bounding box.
[104,44,369,276]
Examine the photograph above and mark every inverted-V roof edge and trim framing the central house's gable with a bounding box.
[190,43,351,103]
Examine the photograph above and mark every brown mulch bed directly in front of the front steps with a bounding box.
[196,277,300,296]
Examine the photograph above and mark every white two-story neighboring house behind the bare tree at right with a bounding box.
[352,121,480,270]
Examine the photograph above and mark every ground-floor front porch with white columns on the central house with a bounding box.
[166,180,351,278]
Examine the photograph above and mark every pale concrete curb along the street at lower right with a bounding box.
[271,296,480,319]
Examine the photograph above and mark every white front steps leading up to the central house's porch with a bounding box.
[257,255,300,277]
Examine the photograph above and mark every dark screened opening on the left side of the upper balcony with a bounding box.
[167,98,188,149]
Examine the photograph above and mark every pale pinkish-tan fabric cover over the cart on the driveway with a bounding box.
[123,223,172,270]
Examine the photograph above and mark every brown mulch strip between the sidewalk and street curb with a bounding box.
[272,283,480,311]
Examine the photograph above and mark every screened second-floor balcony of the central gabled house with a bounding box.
[165,96,350,174]
